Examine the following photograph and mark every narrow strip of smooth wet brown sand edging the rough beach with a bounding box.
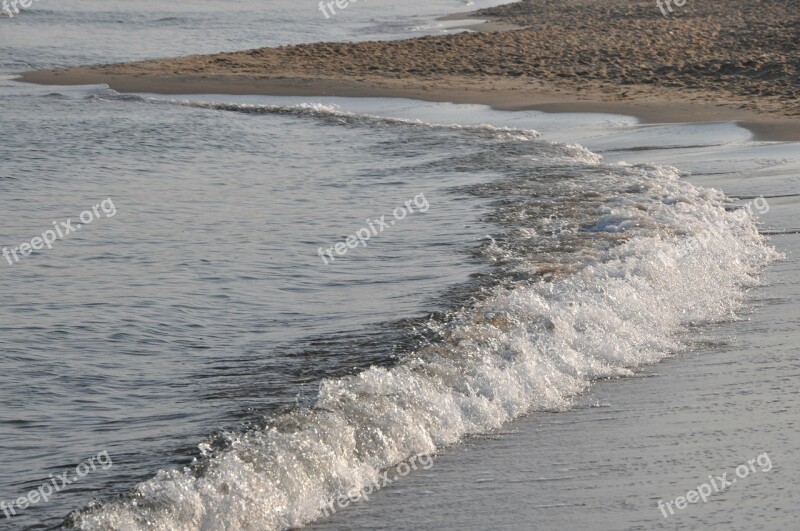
[17,67,800,142]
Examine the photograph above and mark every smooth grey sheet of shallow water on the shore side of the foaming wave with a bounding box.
[298,104,800,530]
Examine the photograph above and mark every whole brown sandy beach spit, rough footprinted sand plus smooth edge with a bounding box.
[22,0,800,140]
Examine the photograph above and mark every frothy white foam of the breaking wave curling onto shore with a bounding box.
[75,139,777,530]
